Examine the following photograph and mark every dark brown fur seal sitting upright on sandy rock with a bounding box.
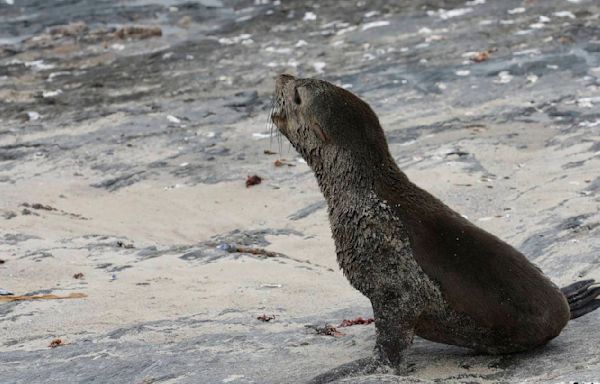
[271,74,600,378]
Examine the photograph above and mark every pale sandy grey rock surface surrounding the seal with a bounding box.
[0,0,600,384]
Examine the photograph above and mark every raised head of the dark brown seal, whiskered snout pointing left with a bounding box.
[271,74,389,168]
